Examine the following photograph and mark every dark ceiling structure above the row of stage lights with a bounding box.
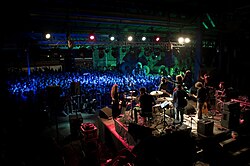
[2,0,250,50]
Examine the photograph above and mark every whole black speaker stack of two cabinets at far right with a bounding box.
[221,101,240,129]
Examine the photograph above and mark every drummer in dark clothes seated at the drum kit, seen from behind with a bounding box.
[139,87,156,124]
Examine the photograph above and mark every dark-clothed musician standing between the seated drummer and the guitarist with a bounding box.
[173,84,189,124]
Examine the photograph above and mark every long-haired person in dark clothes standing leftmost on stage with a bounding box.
[110,84,121,119]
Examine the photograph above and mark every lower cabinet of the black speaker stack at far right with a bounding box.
[221,110,239,129]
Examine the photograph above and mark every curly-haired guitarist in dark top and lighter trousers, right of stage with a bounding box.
[194,81,208,119]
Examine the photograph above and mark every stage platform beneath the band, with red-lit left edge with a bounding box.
[98,109,229,151]
